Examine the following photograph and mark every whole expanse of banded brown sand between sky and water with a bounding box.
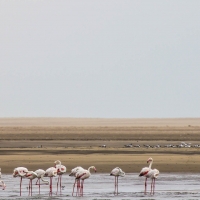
[0,118,200,173]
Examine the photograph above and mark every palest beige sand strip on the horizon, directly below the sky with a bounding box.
[0,117,200,127]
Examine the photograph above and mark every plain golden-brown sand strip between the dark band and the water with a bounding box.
[1,150,200,173]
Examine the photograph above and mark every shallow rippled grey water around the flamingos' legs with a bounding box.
[0,173,200,200]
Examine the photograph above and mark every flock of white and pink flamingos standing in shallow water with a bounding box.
[0,158,159,196]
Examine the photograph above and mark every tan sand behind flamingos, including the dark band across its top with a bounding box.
[0,147,200,173]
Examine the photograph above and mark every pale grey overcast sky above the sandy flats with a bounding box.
[0,0,200,118]
